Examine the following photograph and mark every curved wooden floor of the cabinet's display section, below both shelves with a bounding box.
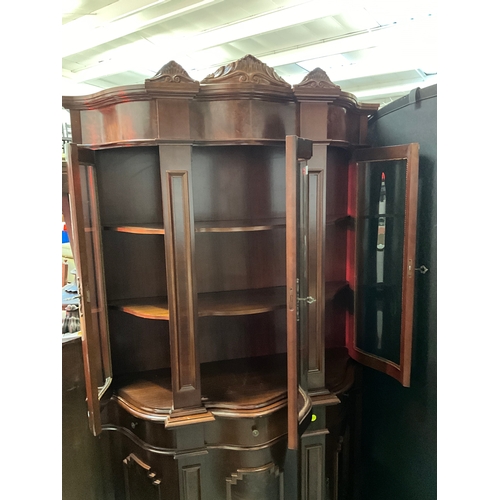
[113,347,348,421]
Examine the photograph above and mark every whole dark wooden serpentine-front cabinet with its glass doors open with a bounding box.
[63,56,418,500]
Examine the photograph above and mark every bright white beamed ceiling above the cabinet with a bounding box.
[62,0,437,105]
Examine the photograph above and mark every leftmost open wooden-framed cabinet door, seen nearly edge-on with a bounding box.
[67,144,112,435]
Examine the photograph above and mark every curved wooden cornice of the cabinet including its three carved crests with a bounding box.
[62,55,378,148]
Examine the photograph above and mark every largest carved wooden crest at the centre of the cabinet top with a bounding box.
[201,55,291,89]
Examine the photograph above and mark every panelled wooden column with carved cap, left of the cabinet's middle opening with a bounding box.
[150,61,214,427]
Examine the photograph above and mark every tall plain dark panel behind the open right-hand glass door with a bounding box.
[358,85,437,500]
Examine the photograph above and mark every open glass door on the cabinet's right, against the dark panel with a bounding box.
[347,144,418,387]
